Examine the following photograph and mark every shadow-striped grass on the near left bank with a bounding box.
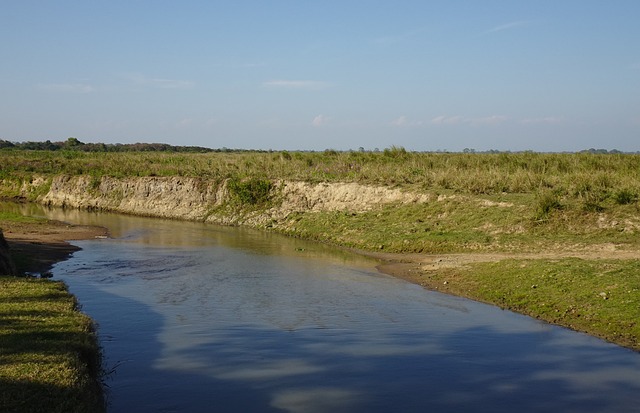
[0,276,105,413]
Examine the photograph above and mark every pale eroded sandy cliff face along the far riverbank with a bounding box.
[26,176,429,225]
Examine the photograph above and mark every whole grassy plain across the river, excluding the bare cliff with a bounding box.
[0,147,640,350]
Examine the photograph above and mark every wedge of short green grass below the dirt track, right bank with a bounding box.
[427,258,640,350]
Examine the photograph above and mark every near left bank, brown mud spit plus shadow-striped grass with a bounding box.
[0,220,107,413]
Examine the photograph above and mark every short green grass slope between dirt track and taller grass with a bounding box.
[274,193,640,253]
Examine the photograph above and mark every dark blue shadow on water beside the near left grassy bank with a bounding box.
[79,287,282,413]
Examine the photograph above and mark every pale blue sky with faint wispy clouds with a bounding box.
[0,0,640,152]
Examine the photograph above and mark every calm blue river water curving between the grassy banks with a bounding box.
[11,204,640,413]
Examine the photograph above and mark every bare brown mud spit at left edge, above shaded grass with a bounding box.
[1,221,108,274]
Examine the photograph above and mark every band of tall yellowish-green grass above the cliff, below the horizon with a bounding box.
[0,147,640,202]
